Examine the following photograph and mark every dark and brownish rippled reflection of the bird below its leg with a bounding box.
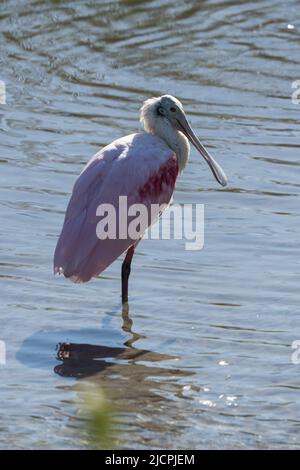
[55,306,192,446]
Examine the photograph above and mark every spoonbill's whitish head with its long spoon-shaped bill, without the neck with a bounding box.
[140,95,227,186]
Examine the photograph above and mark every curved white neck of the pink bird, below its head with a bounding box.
[145,120,190,172]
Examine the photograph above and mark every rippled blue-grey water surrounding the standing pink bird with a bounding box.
[0,0,300,449]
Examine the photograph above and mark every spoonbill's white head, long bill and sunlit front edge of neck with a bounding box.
[140,95,227,186]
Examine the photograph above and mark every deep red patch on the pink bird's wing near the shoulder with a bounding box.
[139,155,179,199]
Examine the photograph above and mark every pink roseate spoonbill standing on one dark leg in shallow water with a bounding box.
[54,95,227,304]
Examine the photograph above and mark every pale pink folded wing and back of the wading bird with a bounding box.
[54,133,178,282]
